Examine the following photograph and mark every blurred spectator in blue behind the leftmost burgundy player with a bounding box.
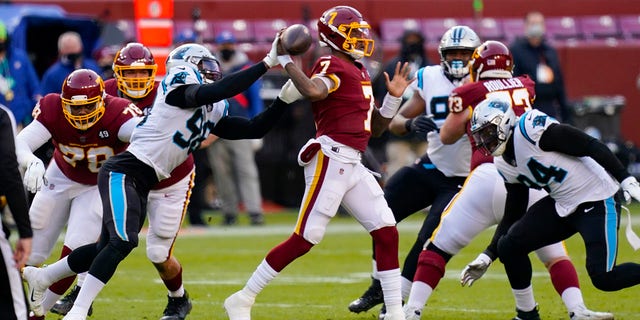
[40,31,102,95]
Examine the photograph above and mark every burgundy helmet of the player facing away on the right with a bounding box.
[469,40,513,81]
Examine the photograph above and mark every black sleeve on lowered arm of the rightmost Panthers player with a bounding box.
[484,183,529,261]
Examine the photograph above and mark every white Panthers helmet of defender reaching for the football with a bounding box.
[166,43,222,83]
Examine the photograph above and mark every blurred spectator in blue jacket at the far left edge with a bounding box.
[0,22,40,127]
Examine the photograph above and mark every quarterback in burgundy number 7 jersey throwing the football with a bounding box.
[224,6,411,320]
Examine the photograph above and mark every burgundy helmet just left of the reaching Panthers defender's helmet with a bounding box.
[112,42,158,99]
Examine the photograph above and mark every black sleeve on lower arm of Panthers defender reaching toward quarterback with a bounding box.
[211,98,288,140]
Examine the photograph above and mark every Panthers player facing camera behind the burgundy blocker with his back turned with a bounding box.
[349,26,480,317]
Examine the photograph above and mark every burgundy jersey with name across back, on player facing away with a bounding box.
[449,75,536,170]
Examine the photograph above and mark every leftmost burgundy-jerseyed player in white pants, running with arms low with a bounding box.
[16,69,141,318]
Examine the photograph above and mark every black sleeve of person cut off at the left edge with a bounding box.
[0,111,33,238]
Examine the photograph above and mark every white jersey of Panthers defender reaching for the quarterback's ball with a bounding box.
[127,66,228,180]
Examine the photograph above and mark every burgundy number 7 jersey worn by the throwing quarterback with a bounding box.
[311,56,374,152]
